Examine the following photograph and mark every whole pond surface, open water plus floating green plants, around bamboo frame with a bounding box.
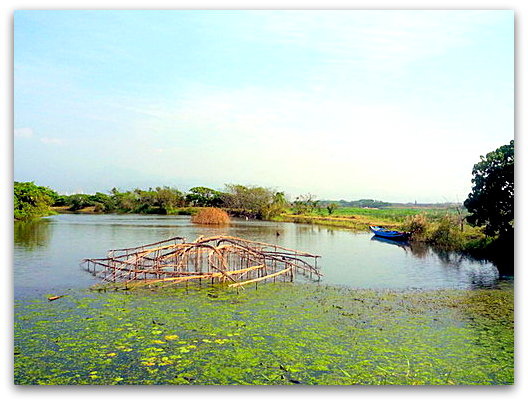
[14,215,513,385]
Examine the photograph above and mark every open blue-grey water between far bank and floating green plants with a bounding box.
[14,214,499,298]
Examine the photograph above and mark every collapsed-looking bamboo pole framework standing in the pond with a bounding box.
[81,236,322,288]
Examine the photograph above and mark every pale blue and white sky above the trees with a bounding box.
[13,10,514,202]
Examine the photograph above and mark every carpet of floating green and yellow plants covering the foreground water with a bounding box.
[14,283,514,385]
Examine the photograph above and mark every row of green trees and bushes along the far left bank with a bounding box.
[14,182,300,220]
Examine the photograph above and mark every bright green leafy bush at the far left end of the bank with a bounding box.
[13,182,59,220]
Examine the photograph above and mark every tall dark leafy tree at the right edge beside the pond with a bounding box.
[464,140,514,237]
